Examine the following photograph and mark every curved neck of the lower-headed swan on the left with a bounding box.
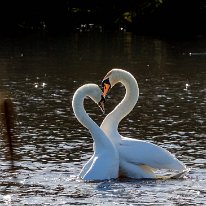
[72,85,112,150]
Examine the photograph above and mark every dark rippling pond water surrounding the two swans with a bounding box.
[0,33,206,206]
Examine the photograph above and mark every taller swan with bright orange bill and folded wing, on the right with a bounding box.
[100,69,186,178]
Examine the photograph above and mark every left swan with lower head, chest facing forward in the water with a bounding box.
[72,84,119,181]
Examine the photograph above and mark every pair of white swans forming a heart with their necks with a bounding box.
[72,69,186,180]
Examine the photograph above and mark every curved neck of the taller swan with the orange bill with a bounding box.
[101,69,139,134]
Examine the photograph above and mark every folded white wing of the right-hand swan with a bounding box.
[119,138,186,171]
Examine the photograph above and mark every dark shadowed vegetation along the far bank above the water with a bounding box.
[0,0,206,35]
